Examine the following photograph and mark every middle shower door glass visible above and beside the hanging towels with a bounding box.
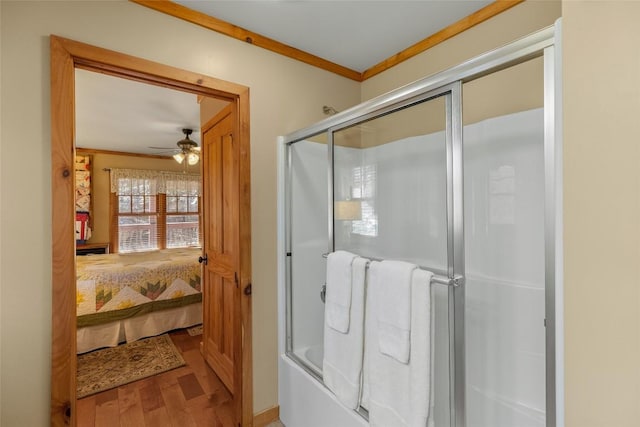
[330,85,462,427]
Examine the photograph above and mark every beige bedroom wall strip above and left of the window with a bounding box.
[80,152,191,246]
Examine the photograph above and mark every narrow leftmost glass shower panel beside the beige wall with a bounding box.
[287,133,329,377]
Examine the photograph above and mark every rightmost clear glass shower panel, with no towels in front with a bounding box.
[463,58,547,427]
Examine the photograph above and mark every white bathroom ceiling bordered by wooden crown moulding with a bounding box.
[174,0,492,72]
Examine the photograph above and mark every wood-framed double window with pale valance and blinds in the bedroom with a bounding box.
[111,169,200,252]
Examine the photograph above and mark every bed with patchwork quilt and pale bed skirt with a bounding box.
[76,248,202,354]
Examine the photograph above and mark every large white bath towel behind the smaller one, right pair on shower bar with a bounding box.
[363,263,433,427]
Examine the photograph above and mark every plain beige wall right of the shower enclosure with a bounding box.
[562,1,640,427]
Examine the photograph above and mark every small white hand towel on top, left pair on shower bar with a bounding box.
[324,251,356,334]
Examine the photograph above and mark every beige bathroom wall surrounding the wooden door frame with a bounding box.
[0,1,360,427]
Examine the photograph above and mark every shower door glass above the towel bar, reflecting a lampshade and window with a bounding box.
[333,96,447,274]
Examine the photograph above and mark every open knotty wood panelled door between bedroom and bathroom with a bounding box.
[202,103,241,394]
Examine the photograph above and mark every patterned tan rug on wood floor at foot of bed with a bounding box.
[77,334,186,399]
